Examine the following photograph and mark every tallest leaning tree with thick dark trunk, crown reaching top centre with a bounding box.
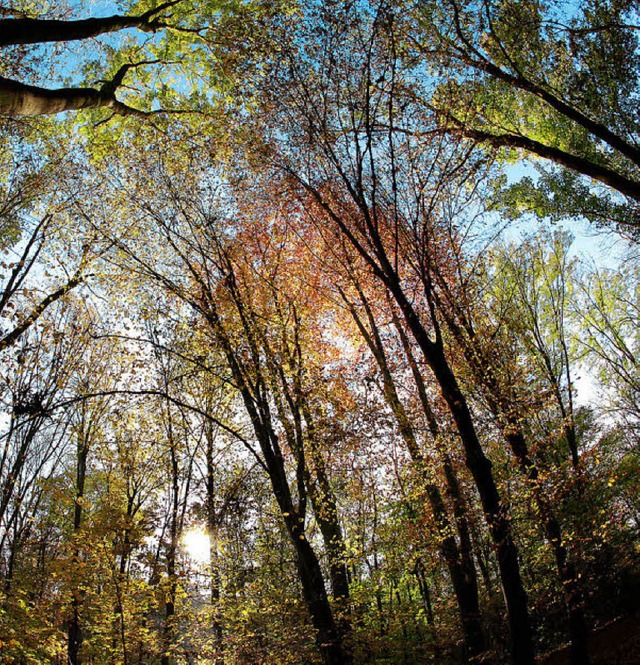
[252,7,534,663]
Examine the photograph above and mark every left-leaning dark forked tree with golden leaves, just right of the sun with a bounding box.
[100,154,350,663]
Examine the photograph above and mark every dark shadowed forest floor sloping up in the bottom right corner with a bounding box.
[540,612,640,665]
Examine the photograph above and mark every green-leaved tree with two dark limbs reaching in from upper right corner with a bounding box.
[405,0,640,226]
